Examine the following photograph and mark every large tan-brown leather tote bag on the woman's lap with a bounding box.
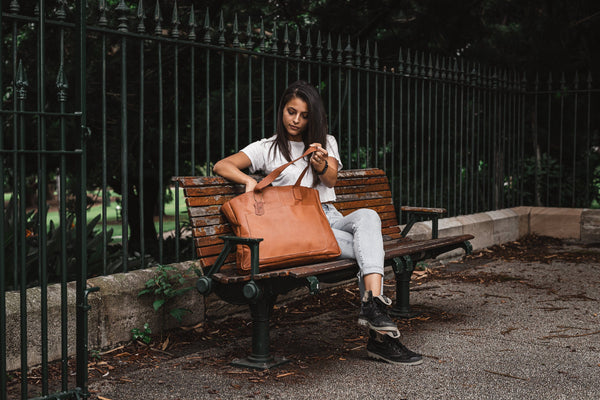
[221,147,341,273]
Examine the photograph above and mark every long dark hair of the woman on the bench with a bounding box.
[271,81,328,161]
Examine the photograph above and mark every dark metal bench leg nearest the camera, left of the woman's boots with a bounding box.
[231,295,289,369]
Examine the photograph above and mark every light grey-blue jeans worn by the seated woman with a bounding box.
[323,204,384,297]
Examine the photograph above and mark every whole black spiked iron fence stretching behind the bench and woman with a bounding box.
[0,0,600,398]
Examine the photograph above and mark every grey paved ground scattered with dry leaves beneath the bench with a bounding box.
[90,241,600,400]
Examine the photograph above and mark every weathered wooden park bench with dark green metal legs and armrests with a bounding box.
[173,169,473,369]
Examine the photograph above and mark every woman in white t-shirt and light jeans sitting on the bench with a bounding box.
[213,81,422,365]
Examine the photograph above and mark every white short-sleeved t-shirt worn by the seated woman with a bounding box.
[241,135,342,203]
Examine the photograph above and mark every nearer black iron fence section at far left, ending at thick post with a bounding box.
[0,1,94,399]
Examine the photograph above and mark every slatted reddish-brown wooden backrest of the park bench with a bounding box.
[173,168,401,270]
